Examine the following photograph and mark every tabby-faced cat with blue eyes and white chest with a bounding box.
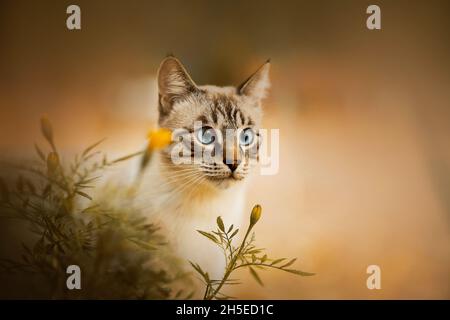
[139,56,270,290]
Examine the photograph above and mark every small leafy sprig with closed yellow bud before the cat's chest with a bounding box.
[190,205,314,300]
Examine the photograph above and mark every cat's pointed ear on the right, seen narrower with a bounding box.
[238,60,270,100]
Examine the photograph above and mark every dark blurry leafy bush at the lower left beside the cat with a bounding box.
[0,118,190,299]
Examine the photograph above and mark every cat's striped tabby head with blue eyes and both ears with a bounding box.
[158,57,270,188]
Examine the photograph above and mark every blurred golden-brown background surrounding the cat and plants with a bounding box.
[0,0,450,299]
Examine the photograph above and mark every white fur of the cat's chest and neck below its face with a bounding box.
[140,156,247,279]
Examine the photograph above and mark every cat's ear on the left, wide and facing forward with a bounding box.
[158,56,197,116]
